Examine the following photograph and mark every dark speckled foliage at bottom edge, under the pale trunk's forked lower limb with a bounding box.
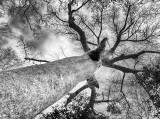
[44,94,107,119]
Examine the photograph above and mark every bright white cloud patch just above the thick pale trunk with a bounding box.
[42,33,80,59]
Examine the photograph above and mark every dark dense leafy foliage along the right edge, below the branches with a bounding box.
[138,63,160,116]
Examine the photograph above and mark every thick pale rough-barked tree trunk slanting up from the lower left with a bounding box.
[0,39,107,119]
